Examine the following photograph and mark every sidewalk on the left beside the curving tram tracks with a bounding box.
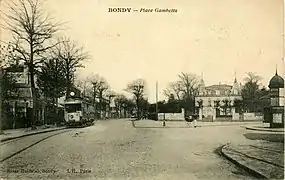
[0,126,65,142]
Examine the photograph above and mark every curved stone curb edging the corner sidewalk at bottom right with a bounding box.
[221,144,268,179]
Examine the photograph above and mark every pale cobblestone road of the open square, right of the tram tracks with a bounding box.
[1,120,252,180]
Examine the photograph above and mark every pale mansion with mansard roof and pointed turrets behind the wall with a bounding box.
[195,75,242,120]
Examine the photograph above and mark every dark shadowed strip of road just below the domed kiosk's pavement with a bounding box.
[244,133,284,144]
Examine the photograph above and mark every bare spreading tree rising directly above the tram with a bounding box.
[52,38,90,94]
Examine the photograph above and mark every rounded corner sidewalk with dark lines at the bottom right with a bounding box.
[221,141,284,179]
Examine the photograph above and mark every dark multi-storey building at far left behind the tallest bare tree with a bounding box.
[4,65,44,128]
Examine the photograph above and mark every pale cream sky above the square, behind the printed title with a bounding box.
[1,0,285,102]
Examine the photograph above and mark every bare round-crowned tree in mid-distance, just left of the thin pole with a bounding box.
[126,79,146,118]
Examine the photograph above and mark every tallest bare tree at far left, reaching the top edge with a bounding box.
[1,0,59,129]
